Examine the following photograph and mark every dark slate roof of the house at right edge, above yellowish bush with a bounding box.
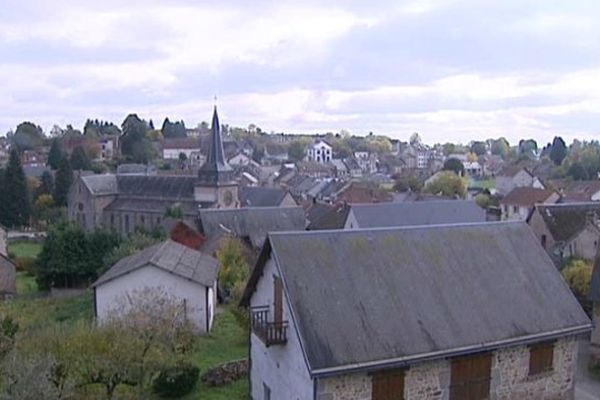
[536,202,600,242]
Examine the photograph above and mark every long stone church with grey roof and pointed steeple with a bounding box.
[67,107,239,234]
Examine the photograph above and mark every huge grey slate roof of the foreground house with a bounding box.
[242,222,591,376]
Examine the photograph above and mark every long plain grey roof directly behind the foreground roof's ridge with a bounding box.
[352,200,485,228]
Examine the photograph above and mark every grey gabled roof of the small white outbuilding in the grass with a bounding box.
[92,240,219,286]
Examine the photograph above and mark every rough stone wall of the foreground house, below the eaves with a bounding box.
[317,338,577,400]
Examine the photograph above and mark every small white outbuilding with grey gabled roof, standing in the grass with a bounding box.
[92,240,218,332]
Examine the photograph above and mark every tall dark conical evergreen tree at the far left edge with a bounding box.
[3,149,31,227]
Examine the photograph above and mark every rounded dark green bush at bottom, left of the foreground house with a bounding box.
[152,362,200,398]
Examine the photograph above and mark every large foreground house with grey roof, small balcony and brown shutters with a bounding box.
[241,223,591,400]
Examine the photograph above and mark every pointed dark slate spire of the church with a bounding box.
[198,105,233,186]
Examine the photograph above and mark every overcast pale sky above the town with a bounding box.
[0,0,600,144]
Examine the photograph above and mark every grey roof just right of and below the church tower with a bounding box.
[199,207,305,248]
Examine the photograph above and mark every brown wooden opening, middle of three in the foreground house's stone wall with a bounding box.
[450,353,492,400]
